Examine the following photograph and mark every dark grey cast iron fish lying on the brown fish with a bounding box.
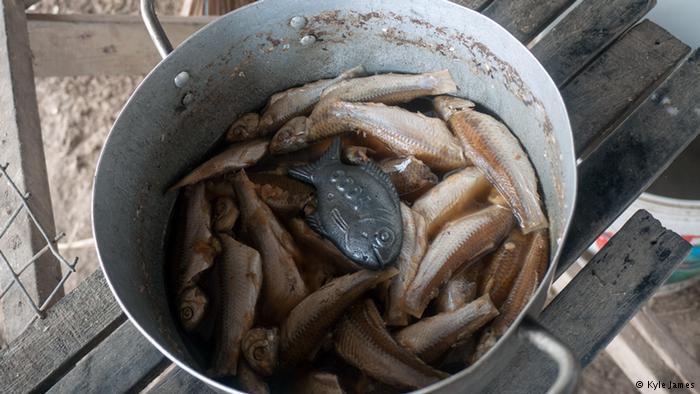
[289,138,403,269]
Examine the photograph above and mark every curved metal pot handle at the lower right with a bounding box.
[518,316,581,394]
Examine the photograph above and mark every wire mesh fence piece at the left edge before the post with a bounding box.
[0,163,78,331]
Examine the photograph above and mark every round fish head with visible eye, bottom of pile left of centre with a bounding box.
[241,327,280,376]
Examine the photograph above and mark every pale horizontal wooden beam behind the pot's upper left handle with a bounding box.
[28,14,214,77]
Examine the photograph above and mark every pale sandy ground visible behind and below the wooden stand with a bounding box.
[27,0,700,394]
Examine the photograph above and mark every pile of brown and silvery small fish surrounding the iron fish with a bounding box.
[167,67,549,393]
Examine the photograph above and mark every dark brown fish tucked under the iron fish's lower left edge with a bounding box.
[288,218,360,274]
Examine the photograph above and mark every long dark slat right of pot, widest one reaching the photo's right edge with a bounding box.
[557,51,700,276]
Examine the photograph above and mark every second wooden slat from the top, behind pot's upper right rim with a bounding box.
[532,0,656,86]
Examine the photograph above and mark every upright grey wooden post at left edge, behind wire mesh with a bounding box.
[0,0,62,342]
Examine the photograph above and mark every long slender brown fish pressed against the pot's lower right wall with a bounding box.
[472,230,549,362]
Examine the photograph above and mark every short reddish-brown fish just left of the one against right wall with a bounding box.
[479,229,530,308]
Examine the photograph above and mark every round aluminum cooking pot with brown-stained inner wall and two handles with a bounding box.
[92,0,577,393]
